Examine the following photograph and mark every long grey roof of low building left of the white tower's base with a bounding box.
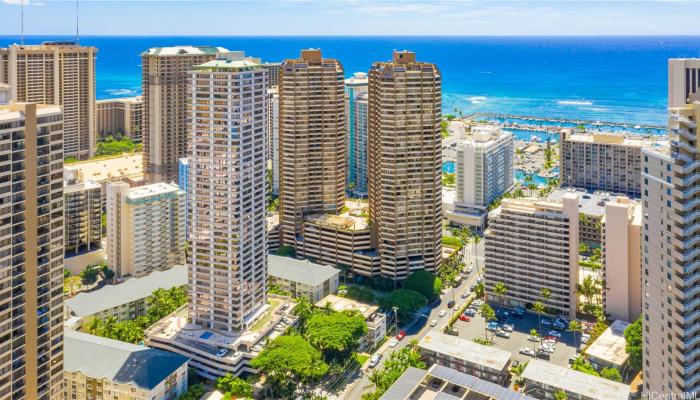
[66,265,187,317]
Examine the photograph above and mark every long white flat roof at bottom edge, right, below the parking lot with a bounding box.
[521,358,630,400]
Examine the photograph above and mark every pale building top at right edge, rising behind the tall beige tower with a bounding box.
[668,58,700,107]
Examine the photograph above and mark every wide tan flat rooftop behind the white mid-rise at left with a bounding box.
[66,153,143,182]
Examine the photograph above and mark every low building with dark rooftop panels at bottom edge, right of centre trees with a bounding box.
[379,364,535,400]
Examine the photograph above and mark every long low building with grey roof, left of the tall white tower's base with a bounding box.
[64,265,187,328]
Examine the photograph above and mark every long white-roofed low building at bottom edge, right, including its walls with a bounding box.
[521,358,630,400]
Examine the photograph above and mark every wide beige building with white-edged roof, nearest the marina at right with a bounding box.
[559,129,655,198]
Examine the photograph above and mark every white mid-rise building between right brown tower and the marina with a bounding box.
[447,126,513,230]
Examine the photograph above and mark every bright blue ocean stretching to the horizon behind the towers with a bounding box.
[0,35,700,125]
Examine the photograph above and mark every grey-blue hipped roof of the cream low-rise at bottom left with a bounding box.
[63,329,189,391]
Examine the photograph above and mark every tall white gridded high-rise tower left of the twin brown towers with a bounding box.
[188,52,267,333]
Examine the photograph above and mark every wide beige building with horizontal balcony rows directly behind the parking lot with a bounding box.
[484,193,579,318]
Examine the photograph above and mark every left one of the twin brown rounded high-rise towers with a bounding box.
[279,49,345,246]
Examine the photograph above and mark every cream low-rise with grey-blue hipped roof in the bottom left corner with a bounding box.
[63,330,188,400]
